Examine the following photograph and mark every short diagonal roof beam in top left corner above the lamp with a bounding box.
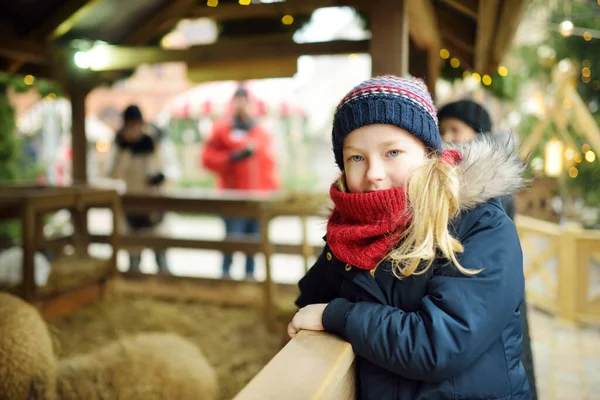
[29,0,100,40]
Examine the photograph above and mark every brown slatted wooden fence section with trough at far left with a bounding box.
[0,185,120,319]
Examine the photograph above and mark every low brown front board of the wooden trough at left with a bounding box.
[36,282,104,321]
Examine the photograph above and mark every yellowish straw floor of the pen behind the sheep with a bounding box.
[52,298,280,399]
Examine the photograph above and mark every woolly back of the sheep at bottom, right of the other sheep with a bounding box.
[58,333,218,400]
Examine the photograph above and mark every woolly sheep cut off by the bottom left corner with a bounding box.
[0,292,57,400]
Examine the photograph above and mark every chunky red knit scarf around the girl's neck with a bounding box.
[327,184,410,270]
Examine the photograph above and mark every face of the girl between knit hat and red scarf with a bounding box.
[343,124,427,193]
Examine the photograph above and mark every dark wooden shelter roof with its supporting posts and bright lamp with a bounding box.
[0,0,526,184]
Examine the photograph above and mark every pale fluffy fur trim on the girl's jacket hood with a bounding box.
[445,133,525,210]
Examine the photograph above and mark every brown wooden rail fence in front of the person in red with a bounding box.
[91,190,327,329]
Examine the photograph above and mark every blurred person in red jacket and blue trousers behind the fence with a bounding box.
[202,86,279,279]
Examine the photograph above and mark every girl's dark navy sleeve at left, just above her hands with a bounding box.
[296,247,343,308]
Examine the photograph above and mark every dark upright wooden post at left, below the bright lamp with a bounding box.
[69,79,90,185]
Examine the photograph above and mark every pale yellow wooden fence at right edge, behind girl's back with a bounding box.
[516,216,600,322]
